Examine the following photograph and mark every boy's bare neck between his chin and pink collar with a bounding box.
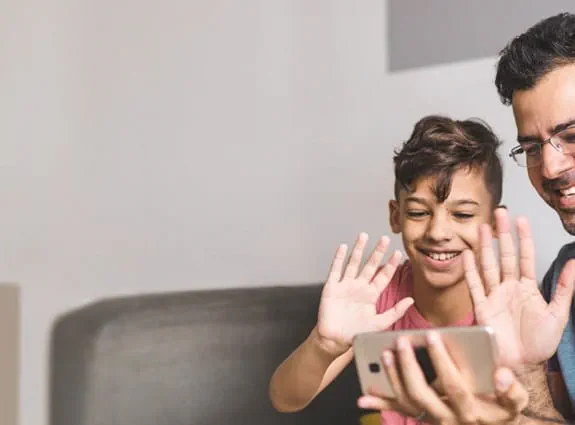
[413,276,473,327]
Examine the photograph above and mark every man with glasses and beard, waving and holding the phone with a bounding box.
[358,13,575,424]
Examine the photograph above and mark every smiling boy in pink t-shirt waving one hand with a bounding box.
[270,116,502,424]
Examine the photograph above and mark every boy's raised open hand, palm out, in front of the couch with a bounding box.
[317,233,413,355]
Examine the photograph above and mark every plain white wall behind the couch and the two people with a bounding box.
[0,0,567,425]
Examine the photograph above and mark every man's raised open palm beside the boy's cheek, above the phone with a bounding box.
[463,209,575,367]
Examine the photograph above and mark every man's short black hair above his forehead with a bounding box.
[495,13,575,105]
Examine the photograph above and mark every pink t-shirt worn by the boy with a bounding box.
[376,261,475,425]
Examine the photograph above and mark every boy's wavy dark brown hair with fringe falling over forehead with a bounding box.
[393,115,503,206]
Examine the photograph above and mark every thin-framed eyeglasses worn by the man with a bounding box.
[509,124,575,168]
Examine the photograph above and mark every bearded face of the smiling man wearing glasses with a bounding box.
[512,64,575,235]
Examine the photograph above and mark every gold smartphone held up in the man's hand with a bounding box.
[353,326,497,398]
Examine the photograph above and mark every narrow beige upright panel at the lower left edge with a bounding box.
[0,284,20,425]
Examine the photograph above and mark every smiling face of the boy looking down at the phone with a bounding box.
[389,169,492,288]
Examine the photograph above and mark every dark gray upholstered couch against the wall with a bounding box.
[50,285,362,425]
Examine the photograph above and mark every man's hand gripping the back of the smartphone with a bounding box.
[358,331,528,425]
